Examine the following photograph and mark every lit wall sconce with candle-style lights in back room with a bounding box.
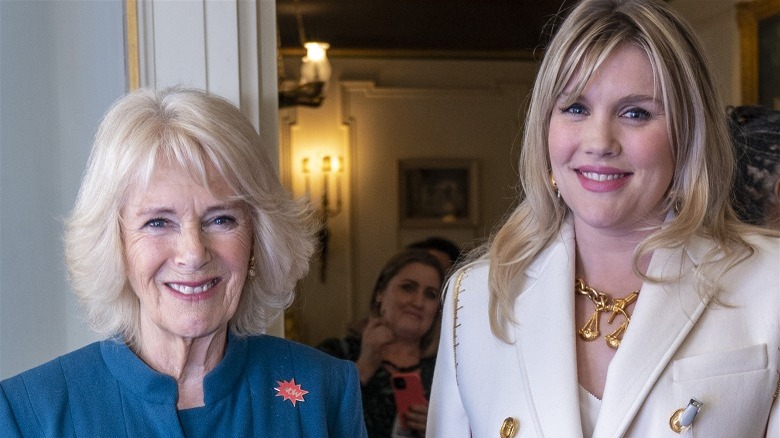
[301,155,344,283]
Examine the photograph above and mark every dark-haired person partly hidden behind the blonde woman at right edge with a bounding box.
[729,105,780,230]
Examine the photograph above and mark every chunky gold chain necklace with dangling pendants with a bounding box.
[574,278,639,349]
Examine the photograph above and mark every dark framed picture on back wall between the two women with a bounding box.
[398,159,479,228]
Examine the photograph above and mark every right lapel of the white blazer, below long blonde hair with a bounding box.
[593,240,709,437]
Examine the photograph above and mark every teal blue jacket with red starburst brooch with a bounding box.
[0,335,366,437]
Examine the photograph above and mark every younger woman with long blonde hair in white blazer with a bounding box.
[428,0,780,438]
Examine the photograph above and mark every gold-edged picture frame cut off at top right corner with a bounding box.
[737,0,780,109]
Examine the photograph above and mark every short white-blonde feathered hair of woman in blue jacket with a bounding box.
[65,87,316,345]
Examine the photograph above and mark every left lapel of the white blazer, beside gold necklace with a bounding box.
[515,224,582,437]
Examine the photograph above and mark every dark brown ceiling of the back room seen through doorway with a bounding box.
[276,0,575,59]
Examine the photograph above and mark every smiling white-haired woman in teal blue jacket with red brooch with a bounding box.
[0,88,365,437]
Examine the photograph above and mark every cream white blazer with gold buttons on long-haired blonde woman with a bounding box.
[427,225,780,438]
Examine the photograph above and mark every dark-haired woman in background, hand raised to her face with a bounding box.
[318,249,444,438]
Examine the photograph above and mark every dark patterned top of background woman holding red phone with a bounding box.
[317,336,436,438]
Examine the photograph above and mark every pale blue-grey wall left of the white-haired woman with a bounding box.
[0,0,125,377]
